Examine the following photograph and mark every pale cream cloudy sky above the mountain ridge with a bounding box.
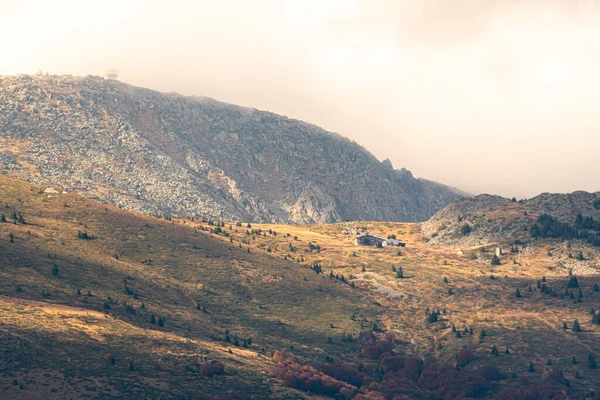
[0,0,600,198]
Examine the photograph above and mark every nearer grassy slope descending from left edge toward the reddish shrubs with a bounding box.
[0,176,377,399]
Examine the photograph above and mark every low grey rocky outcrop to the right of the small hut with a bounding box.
[421,191,600,248]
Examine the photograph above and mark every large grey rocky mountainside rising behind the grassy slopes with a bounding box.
[0,76,462,223]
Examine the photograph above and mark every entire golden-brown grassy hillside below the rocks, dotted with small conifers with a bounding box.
[0,177,600,399]
